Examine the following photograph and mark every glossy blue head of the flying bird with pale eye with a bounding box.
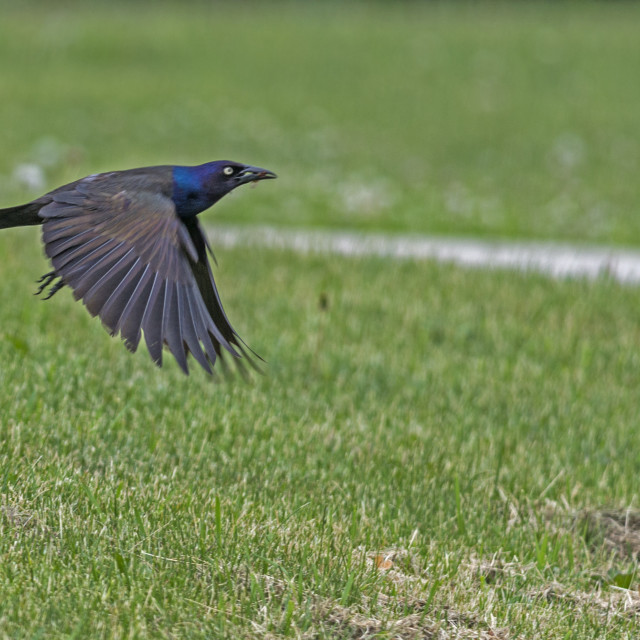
[172,160,276,218]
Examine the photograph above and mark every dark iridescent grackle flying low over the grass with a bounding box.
[0,161,276,374]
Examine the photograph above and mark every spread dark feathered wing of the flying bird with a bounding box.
[40,181,244,373]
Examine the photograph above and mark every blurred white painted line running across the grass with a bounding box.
[208,225,640,283]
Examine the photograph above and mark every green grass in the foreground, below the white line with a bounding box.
[0,230,640,638]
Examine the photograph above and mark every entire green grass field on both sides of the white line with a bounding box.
[0,3,640,640]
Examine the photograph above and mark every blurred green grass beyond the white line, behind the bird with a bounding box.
[0,2,640,244]
